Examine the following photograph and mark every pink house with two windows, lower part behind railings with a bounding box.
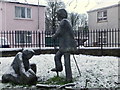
[0,1,45,45]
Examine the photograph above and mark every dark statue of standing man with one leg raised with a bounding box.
[51,9,76,81]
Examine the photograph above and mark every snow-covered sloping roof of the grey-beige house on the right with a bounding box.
[88,2,120,13]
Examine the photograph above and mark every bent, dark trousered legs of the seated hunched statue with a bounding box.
[2,64,37,84]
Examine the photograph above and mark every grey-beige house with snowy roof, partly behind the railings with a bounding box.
[87,2,120,47]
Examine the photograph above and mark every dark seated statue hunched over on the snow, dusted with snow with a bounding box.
[2,49,37,85]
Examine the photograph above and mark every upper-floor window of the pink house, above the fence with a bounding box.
[15,6,31,18]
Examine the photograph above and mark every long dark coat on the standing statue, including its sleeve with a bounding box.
[52,19,76,52]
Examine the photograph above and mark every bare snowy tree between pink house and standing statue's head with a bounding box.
[46,0,65,33]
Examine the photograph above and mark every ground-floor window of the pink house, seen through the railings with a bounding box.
[15,31,32,43]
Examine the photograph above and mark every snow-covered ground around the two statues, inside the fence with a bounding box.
[0,54,120,88]
